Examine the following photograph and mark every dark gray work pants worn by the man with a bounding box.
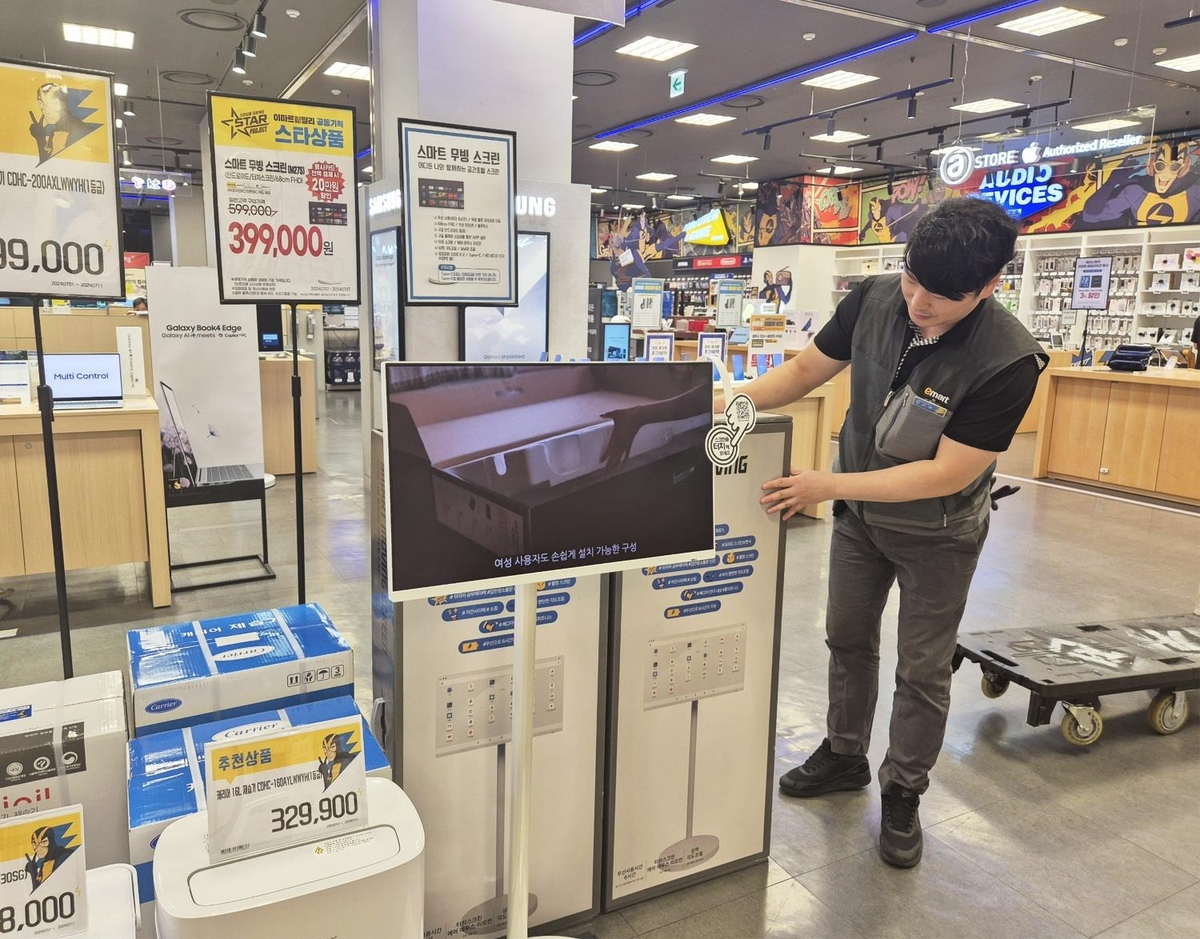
[826,508,988,793]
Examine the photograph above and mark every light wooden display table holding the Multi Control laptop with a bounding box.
[0,397,170,606]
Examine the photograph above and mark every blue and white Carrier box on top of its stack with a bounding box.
[127,603,354,736]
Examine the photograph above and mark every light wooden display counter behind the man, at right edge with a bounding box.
[1033,367,1200,504]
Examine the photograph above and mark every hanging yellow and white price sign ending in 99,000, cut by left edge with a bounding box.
[0,60,125,300]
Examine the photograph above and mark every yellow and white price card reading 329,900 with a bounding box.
[204,717,367,863]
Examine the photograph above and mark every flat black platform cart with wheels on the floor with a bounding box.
[954,614,1200,747]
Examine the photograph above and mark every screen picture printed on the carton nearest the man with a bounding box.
[644,623,746,710]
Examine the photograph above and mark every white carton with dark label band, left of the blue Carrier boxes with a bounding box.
[0,671,130,866]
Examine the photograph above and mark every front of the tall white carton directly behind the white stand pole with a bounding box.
[396,575,606,937]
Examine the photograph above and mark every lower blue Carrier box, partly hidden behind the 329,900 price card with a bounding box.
[126,696,391,935]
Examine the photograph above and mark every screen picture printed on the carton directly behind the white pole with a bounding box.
[433,656,564,756]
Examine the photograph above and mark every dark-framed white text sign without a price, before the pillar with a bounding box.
[400,119,520,306]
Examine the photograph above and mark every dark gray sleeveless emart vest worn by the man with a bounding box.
[835,274,1050,533]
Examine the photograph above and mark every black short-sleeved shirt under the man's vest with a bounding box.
[812,280,1039,453]
